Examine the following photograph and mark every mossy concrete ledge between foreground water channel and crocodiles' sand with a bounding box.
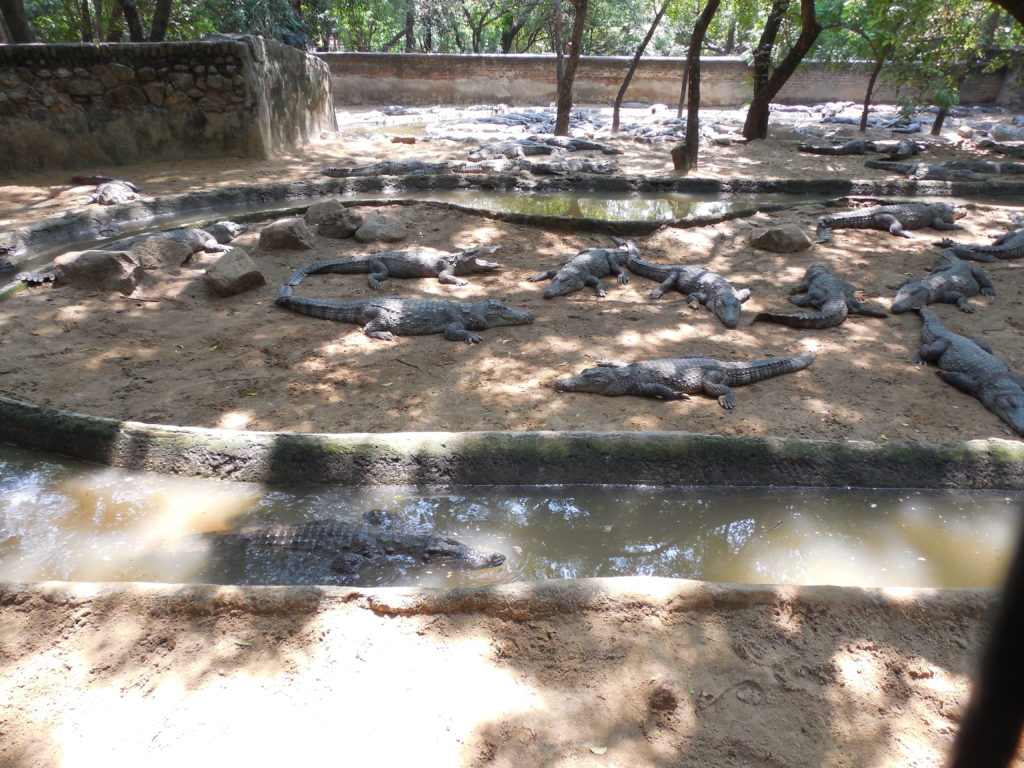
[0,397,1024,490]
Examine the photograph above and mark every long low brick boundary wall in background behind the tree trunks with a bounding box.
[317,53,1002,106]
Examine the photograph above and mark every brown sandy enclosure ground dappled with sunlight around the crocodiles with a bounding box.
[0,107,1024,768]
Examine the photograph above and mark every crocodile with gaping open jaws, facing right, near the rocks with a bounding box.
[288,246,502,291]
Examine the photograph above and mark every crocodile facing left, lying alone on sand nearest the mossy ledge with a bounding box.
[554,351,815,410]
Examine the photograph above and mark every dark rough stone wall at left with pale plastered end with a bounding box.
[0,36,336,175]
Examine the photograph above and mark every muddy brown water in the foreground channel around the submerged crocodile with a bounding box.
[0,446,1022,587]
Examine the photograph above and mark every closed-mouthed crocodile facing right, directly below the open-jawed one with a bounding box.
[275,286,534,344]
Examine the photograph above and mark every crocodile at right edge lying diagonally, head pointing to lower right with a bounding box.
[918,307,1024,435]
